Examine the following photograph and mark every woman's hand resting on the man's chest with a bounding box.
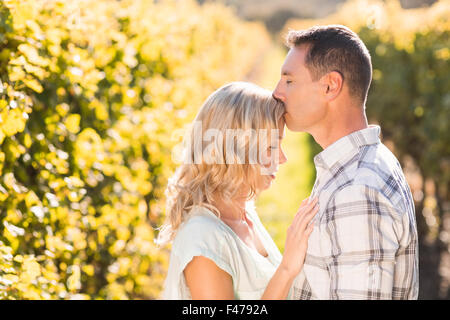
[280,198,319,277]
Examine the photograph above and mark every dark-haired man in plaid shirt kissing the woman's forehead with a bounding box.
[273,25,418,299]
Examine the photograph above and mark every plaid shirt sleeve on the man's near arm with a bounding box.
[323,185,402,300]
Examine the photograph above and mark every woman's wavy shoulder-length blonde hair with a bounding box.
[155,82,285,245]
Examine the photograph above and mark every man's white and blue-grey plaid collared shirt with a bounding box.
[292,125,419,300]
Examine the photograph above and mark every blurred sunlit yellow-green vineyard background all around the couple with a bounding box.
[0,0,450,299]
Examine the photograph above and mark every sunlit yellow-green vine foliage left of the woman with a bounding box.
[0,0,270,299]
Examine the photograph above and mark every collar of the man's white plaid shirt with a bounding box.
[314,125,381,169]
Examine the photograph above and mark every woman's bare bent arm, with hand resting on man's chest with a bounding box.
[184,199,318,300]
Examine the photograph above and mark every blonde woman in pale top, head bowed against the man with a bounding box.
[158,82,318,299]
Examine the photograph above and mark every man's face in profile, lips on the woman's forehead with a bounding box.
[273,45,327,132]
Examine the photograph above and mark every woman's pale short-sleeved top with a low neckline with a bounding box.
[161,202,291,300]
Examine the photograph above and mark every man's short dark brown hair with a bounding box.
[286,25,372,104]
